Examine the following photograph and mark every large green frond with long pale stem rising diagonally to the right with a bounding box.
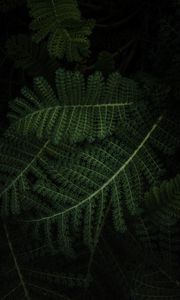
[21,111,179,252]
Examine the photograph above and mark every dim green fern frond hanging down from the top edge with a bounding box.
[28,0,94,61]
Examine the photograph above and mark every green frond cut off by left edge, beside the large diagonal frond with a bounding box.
[0,135,58,216]
